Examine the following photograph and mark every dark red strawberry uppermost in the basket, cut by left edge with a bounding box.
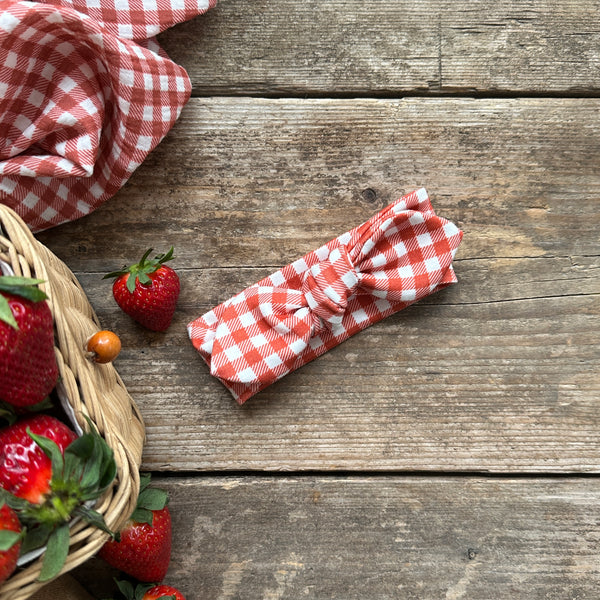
[0,275,58,407]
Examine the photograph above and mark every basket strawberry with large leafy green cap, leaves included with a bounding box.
[0,414,117,581]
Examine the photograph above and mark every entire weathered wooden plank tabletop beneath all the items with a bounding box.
[31,0,600,600]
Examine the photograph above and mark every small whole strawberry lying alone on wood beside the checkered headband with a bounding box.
[104,247,180,331]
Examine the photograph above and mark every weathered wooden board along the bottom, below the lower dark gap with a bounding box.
[76,477,600,600]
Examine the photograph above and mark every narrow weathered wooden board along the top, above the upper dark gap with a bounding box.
[160,0,600,96]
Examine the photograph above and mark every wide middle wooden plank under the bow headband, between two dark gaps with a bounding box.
[40,98,600,472]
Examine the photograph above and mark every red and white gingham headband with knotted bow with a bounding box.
[188,189,462,404]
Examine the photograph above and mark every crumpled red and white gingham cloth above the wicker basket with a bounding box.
[0,0,216,231]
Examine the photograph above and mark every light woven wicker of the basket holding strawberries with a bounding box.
[0,205,145,600]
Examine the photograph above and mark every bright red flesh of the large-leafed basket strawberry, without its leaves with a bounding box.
[0,414,77,504]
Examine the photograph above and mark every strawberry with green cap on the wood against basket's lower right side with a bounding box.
[99,476,171,582]
